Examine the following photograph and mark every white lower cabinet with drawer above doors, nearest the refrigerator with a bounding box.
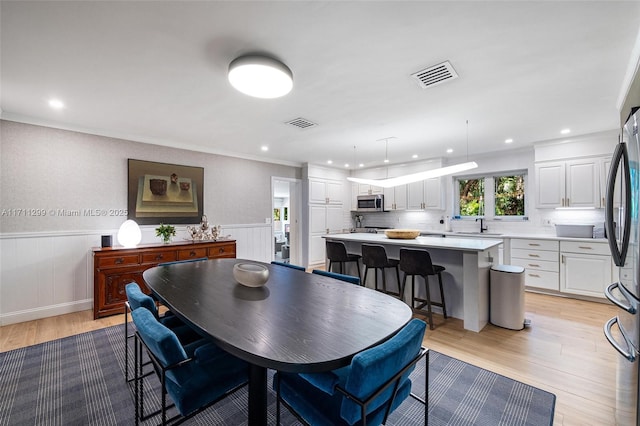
[560,241,612,298]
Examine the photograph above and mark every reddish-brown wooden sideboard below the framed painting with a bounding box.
[93,240,236,319]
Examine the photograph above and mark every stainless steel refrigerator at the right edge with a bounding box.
[604,108,640,426]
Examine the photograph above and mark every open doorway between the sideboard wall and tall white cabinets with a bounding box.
[271,177,302,265]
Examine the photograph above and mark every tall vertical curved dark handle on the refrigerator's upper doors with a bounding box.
[605,142,631,266]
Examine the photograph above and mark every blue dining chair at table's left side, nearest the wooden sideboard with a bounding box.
[124,283,201,382]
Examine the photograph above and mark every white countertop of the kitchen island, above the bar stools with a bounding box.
[323,233,502,252]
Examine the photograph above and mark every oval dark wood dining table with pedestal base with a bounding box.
[143,259,411,425]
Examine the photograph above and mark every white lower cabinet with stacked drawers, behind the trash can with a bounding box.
[511,238,560,291]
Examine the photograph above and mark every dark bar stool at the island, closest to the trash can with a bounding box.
[400,248,447,330]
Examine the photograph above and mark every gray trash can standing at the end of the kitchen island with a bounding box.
[489,265,525,330]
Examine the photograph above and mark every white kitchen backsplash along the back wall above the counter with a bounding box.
[352,209,604,235]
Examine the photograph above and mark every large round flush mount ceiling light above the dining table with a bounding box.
[228,55,293,99]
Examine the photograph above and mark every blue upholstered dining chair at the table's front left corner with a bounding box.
[131,309,249,425]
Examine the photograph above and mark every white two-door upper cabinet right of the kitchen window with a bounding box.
[535,158,601,209]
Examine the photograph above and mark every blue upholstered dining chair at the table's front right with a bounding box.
[273,319,429,426]
